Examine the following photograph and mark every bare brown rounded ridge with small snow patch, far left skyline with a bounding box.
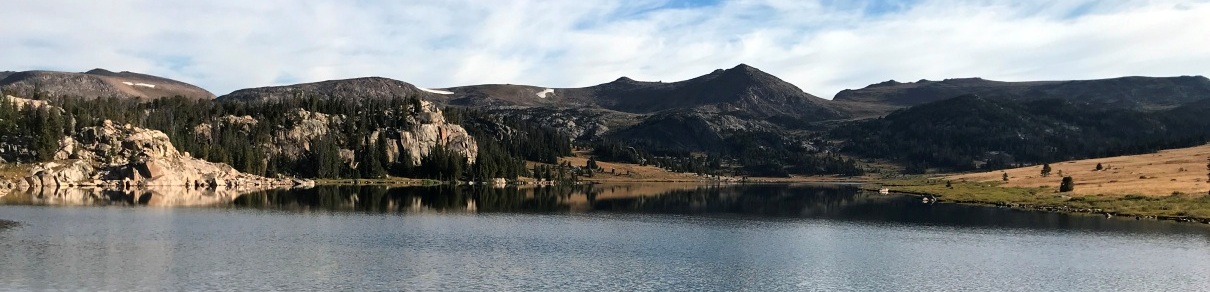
[0,69,214,101]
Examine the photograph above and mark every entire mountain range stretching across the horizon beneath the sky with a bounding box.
[0,64,1210,173]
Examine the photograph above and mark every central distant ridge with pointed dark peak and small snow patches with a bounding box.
[449,64,843,120]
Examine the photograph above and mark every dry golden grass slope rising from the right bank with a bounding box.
[946,144,1210,196]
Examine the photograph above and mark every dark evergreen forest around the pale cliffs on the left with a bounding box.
[0,96,571,181]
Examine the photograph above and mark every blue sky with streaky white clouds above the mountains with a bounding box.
[0,0,1210,98]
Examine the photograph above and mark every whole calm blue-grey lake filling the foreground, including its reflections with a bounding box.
[0,184,1210,291]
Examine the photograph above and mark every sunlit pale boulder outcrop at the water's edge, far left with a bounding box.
[24,121,294,188]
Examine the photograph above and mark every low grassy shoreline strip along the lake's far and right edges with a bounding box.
[7,165,1210,225]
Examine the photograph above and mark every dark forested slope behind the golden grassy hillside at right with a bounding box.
[830,96,1210,173]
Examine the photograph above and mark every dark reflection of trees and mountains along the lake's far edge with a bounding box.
[234,184,1210,233]
